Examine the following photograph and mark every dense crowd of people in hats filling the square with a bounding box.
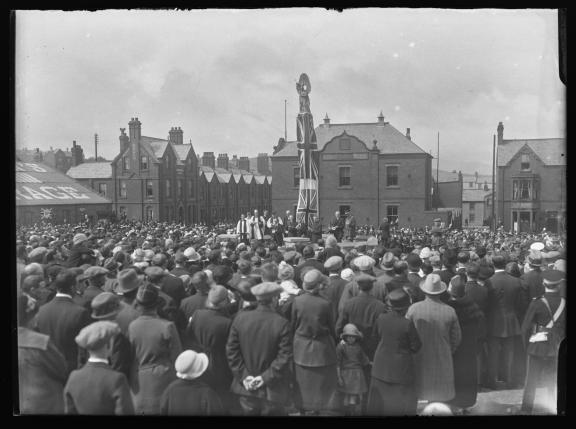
[16,216,566,416]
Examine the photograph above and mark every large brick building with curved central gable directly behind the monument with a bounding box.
[272,113,443,228]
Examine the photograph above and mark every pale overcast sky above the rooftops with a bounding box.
[16,9,565,173]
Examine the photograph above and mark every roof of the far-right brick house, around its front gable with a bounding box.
[498,138,566,167]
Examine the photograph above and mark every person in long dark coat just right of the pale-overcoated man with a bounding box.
[448,275,485,414]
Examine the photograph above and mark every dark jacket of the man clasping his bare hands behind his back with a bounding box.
[226,305,292,404]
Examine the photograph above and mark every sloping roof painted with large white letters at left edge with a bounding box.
[16,162,110,206]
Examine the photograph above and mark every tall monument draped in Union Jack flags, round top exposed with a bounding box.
[296,73,318,226]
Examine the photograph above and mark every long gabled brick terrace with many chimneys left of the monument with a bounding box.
[68,118,271,224]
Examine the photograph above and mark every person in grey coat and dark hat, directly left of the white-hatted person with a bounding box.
[128,283,182,415]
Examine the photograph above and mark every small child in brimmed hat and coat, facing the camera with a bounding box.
[336,323,370,415]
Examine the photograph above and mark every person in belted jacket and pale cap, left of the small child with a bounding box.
[291,269,338,415]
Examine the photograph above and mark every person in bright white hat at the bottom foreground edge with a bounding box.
[160,350,226,416]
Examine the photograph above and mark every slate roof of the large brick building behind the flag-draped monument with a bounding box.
[273,123,426,157]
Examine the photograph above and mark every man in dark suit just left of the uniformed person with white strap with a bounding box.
[487,254,525,389]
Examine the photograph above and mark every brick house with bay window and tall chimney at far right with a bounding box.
[496,122,566,233]
